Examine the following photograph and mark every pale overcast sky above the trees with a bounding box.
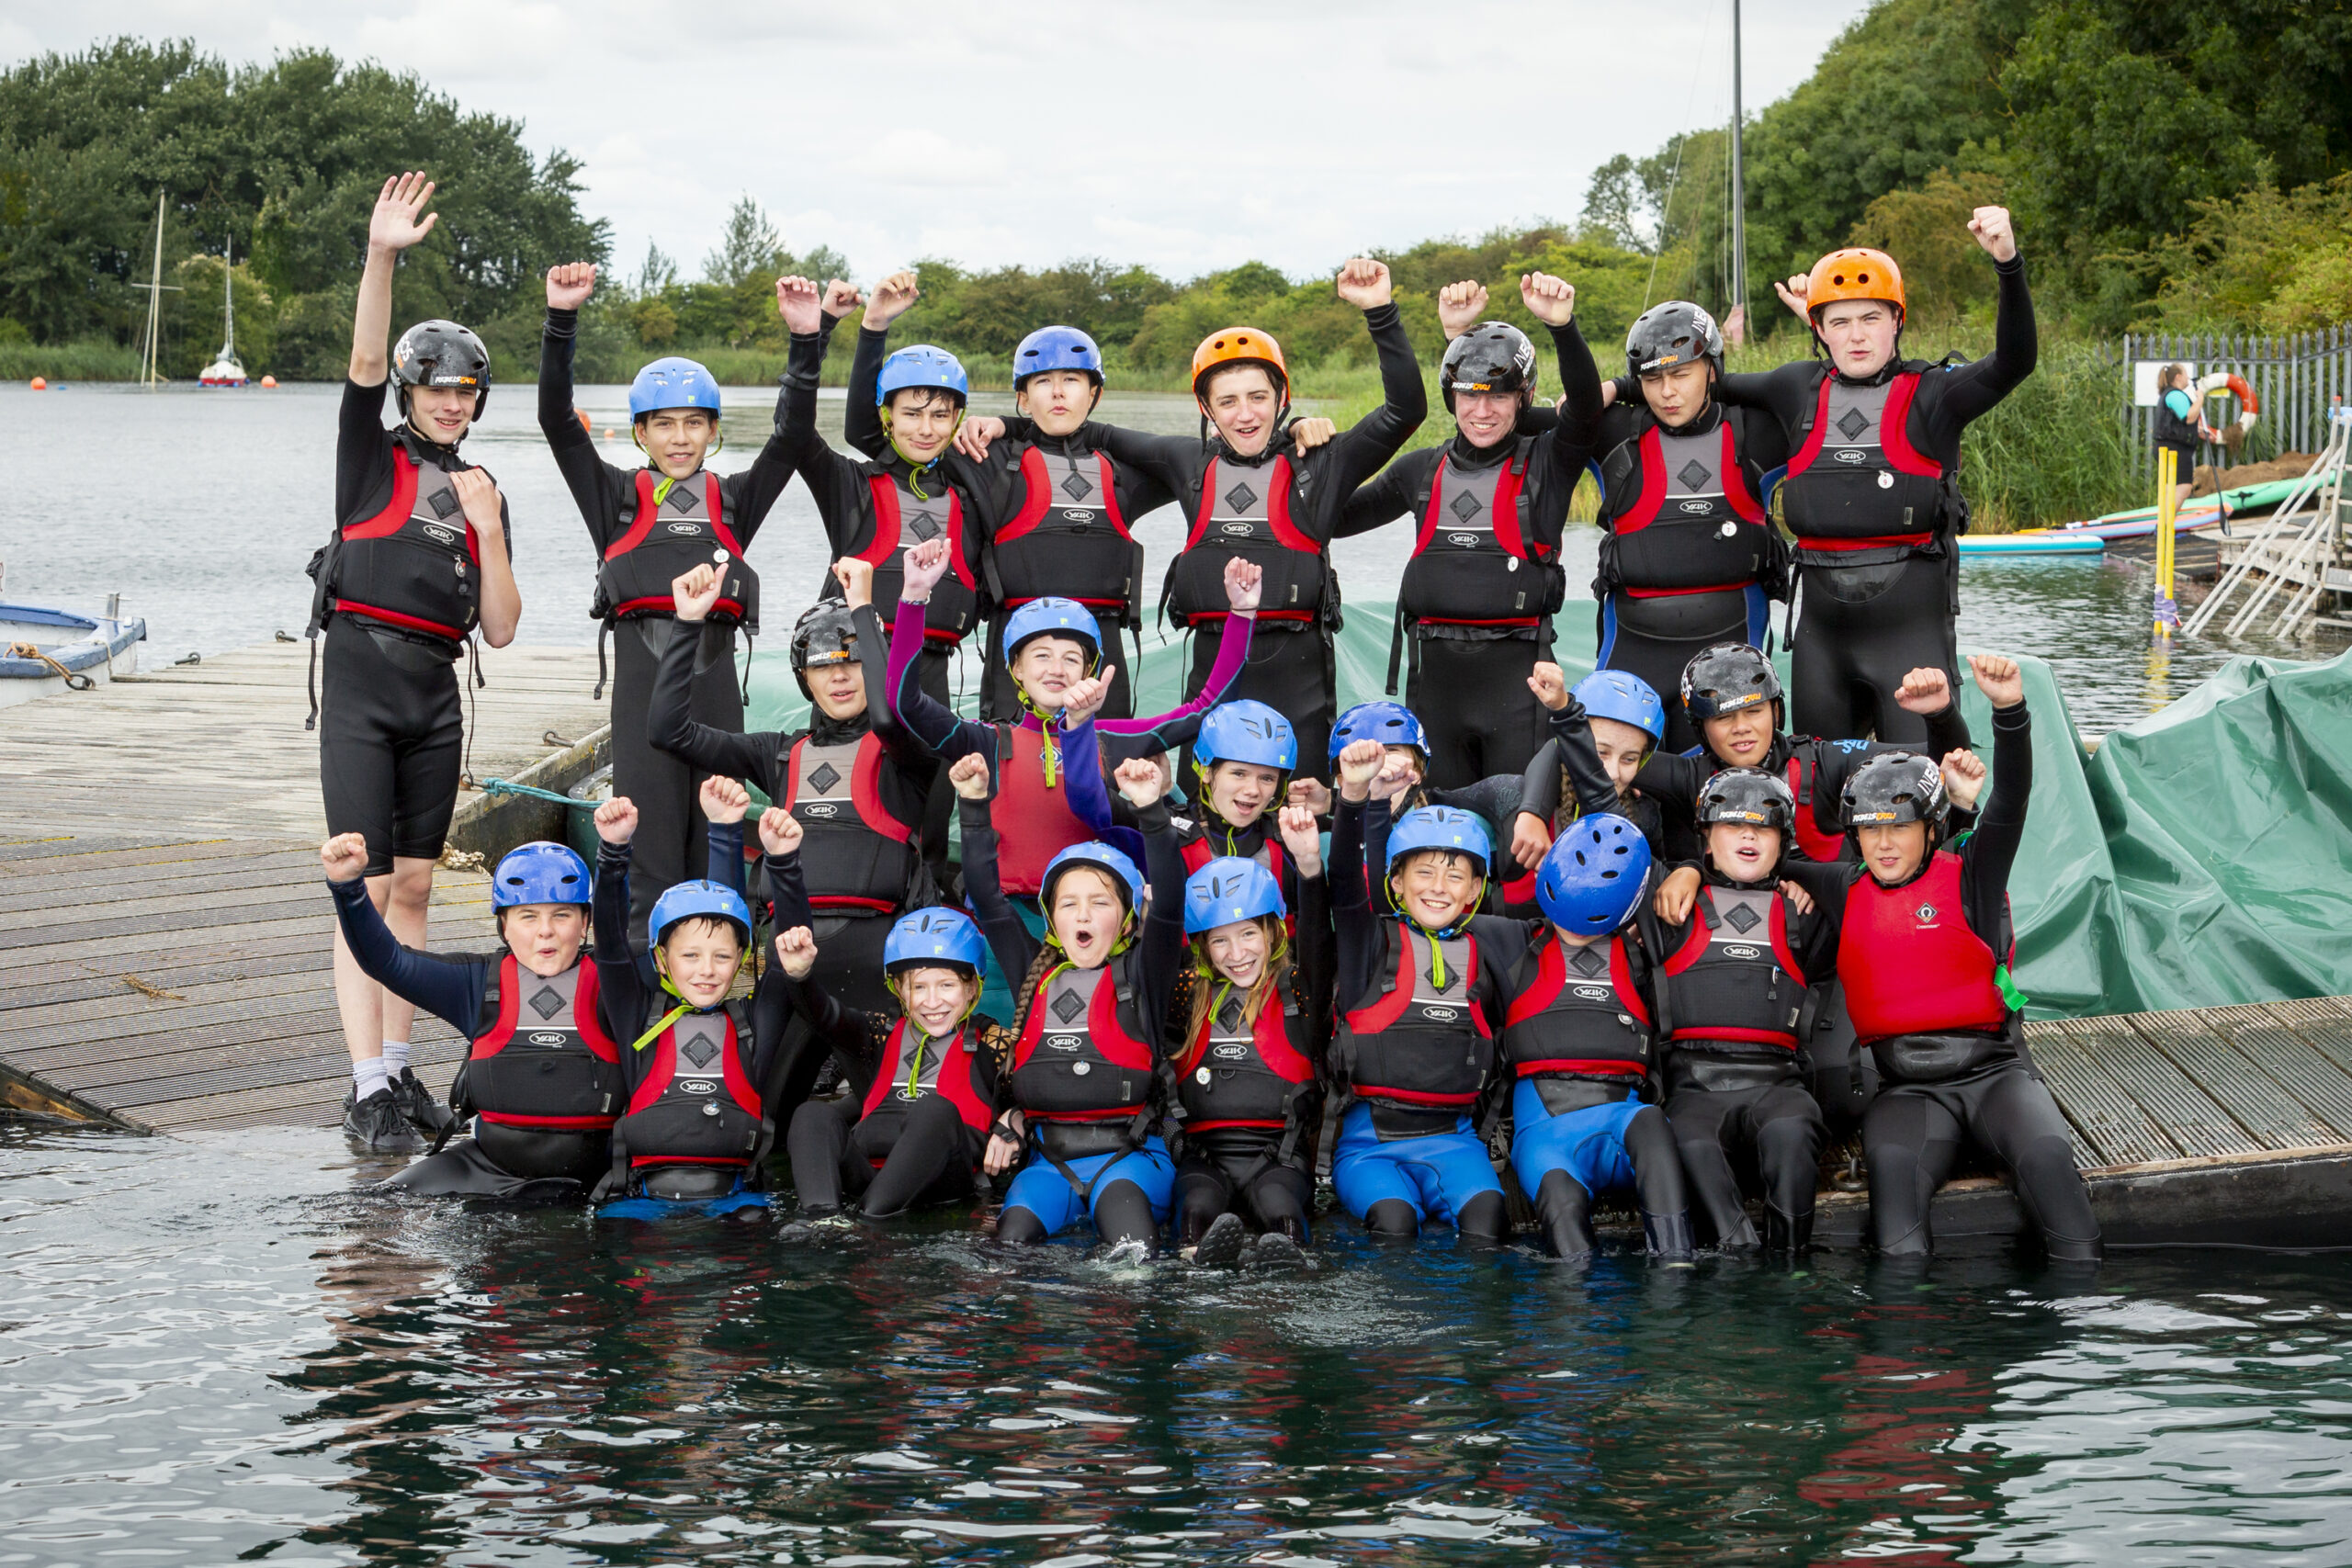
[0,0,1868,280]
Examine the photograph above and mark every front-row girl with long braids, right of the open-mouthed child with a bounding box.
[1146,807,1331,1265]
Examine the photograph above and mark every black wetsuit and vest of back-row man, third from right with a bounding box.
[1334,322,1601,787]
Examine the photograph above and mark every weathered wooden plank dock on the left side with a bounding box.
[0,644,605,1131]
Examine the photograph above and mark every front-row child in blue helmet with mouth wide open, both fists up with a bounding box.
[948,755,1183,1251]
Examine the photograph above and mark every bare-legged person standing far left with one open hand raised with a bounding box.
[308,174,522,1155]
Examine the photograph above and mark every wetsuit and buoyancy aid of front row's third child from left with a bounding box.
[783,982,1013,1220]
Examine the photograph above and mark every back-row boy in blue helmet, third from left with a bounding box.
[776,273,997,709]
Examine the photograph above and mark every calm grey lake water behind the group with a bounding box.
[0,386,2310,733]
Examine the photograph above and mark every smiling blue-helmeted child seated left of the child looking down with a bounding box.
[1331,740,1526,1241]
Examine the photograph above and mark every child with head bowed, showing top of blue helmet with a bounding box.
[1503,811,1691,1258]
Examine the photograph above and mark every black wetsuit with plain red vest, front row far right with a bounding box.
[1788,703,2100,1260]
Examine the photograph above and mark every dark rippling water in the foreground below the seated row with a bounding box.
[0,1134,2352,1568]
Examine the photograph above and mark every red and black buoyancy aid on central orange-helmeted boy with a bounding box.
[1164,456,1339,627]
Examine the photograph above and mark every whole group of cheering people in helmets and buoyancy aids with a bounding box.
[312,174,2100,1262]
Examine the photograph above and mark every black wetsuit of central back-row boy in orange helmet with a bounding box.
[1080,306,1430,776]
